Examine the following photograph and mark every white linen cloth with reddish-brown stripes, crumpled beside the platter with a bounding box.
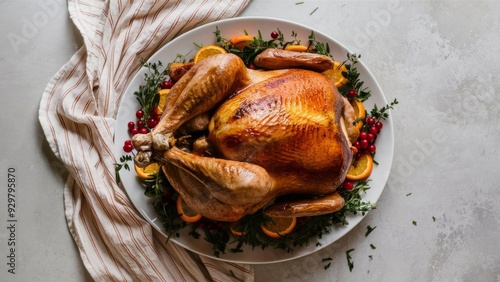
[39,0,254,281]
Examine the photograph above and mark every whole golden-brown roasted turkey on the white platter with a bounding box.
[133,50,359,221]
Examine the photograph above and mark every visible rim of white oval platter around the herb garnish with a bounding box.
[114,17,394,264]
